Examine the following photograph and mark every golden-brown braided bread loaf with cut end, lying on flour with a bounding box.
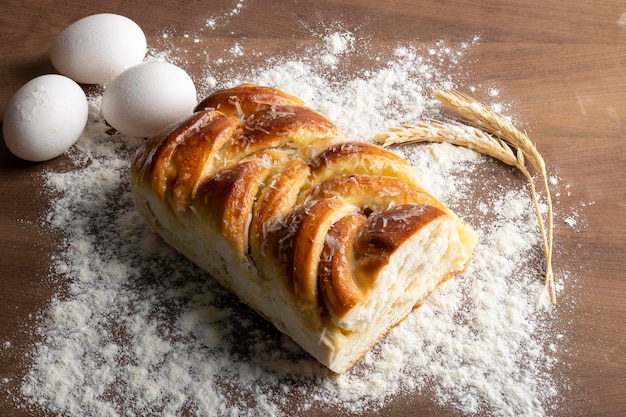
[131,84,476,373]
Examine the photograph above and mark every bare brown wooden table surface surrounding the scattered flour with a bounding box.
[0,0,626,416]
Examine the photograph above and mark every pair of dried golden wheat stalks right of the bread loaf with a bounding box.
[374,90,556,304]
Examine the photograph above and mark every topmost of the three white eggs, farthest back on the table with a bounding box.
[50,13,147,84]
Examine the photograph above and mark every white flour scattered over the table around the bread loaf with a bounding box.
[6,17,571,417]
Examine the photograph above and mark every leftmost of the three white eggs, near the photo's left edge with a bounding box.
[2,74,89,161]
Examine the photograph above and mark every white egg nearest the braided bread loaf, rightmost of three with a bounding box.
[102,61,197,137]
